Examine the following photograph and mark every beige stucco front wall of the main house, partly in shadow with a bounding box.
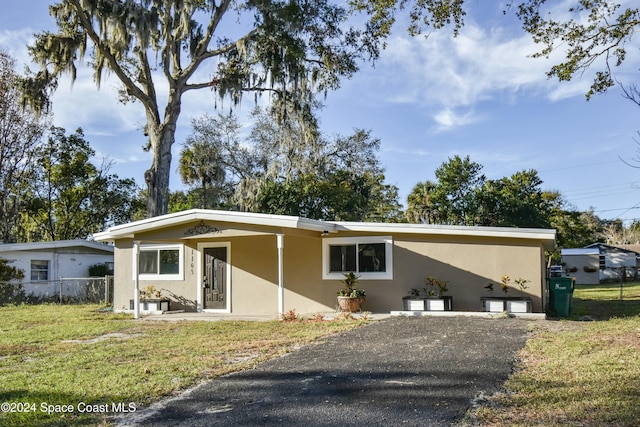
[114,230,544,315]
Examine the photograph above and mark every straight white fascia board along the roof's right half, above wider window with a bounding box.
[335,222,556,243]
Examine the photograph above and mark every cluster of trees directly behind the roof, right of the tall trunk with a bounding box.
[178,108,401,221]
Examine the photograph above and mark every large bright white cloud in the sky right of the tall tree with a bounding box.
[372,18,585,128]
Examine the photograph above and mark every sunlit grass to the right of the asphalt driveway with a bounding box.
[474,283,640,427]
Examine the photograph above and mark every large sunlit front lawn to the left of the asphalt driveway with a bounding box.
[0,305,361,426]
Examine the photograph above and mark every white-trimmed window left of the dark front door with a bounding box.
[134,245,184,280]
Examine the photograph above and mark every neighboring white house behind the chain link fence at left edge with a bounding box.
[0,240,113,296]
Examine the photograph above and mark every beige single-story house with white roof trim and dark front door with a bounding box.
[94,209,555,315]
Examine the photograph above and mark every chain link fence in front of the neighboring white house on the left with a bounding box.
[0,276,113,306]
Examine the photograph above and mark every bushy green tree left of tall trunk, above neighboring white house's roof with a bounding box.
[22,128,137,241]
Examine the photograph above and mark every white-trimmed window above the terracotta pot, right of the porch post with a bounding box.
[322,236,393,280]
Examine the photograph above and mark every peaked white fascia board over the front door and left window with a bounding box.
[93,209,336,241]
